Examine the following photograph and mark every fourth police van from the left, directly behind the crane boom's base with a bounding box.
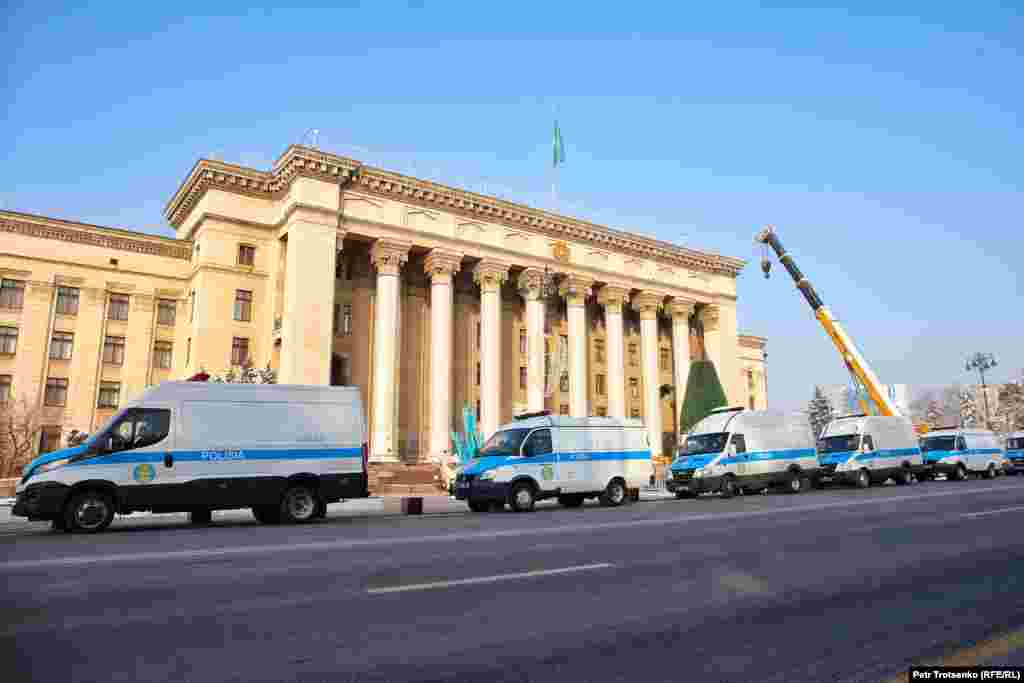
[818,415,924,488]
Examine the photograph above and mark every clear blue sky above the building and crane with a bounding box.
[0,0,1024,410]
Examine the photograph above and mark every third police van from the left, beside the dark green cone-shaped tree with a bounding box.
[666,408,818,498]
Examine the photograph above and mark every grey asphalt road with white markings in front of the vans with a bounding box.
[0,477,1024,682]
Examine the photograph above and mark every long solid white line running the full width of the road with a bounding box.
[0,486,1019,572]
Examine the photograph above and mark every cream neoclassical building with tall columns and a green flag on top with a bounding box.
[0,146,767,473]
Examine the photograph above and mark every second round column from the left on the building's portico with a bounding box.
[424,249,462,462]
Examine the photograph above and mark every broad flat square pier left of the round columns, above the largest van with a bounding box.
[280,210,338,385]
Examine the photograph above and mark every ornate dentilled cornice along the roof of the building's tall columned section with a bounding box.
[164,145,745,278]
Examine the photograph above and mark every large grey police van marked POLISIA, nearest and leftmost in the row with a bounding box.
[11,382,369,532]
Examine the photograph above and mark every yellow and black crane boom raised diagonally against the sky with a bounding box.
[755,225,901,416]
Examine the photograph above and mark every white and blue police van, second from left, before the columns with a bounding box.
[455,411,653,512]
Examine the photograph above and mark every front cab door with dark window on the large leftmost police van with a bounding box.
[82,405,181,509]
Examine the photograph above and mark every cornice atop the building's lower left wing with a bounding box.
[0,211,191,261]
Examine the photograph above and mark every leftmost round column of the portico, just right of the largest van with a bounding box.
[370,240,409,462]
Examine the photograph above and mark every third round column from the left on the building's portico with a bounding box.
[473,260,509,440]
